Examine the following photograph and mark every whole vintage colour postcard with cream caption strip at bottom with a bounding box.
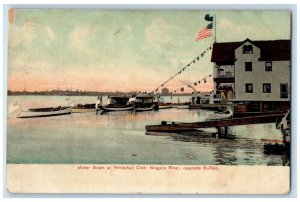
[6,9,293,194]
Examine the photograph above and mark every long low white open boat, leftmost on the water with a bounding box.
[17,106,72,118]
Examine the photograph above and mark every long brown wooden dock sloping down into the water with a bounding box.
[146,113,285,135]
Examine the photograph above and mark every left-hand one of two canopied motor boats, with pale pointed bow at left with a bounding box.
[100,96,134,112]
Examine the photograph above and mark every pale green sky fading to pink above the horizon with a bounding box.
[8,9,291,92]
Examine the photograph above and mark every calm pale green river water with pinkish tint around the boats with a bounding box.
[7,96,283,165]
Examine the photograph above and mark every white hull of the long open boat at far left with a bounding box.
[17,107,72,118]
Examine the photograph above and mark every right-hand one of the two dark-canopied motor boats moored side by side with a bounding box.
[134,95,154,112]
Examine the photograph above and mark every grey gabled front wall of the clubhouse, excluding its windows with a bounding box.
[235,42,290,101]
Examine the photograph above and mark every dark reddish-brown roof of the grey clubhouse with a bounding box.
[211,39,291,64]
